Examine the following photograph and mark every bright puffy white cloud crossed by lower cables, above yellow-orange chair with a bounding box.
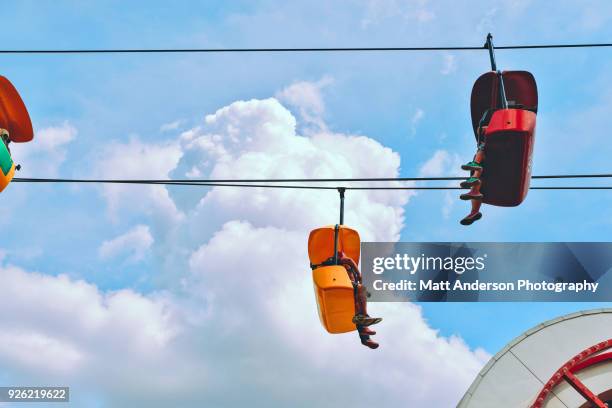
[173,98,411,240]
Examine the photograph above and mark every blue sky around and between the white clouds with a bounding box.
[0,0,612,405]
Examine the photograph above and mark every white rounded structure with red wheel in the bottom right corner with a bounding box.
[458,309,612,408]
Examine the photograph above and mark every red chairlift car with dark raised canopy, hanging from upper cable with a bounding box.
[462,34,538,225]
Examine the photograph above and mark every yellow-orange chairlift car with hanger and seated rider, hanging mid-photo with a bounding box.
[308,188,382,348]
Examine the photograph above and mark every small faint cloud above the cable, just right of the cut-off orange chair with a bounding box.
[11,122,77,178]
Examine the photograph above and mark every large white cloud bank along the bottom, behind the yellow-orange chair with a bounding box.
[0,217,488,407]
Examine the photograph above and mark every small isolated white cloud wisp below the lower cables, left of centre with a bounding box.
[98,225,154,262]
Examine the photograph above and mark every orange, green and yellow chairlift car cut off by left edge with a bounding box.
[0,76,34,192]
